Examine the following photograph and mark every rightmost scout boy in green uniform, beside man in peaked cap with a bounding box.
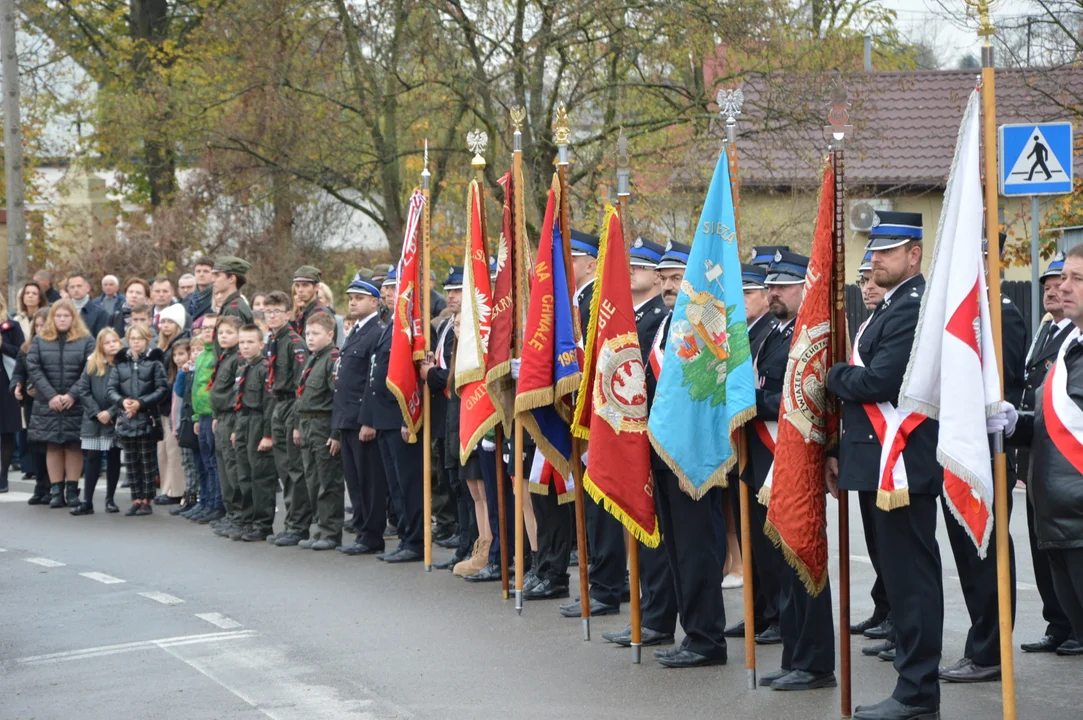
[293,313,345,550]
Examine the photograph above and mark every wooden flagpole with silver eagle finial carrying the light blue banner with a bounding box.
[717,88,759,690]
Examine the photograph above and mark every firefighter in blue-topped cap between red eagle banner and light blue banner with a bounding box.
[602,237,677,647]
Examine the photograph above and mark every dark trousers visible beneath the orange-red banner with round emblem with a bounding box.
[779,559,835,675]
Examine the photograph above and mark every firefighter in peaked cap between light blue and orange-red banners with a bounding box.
[748,250,837,691]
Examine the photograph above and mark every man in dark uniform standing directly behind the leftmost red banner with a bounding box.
[360,269,420,563]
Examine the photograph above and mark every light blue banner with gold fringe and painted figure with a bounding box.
[648,147,756,493]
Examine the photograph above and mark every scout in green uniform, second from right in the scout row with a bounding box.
[263,291,312,547]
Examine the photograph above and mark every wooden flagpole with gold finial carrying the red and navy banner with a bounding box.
[552,103,590,641]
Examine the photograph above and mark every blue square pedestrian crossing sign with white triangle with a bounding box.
[1000,122,1072,196]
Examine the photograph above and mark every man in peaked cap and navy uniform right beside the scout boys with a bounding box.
[331,277,388,555]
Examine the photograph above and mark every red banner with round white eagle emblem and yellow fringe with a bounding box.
[572,207,661,548]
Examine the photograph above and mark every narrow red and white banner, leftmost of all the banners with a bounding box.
[387,191,425,443]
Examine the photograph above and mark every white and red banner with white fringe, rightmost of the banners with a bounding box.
[899,90,1001,558]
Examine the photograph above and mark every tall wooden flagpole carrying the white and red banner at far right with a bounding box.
[974,0,1016,720]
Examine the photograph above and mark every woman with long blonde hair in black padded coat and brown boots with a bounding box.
[26,300,94,508]
